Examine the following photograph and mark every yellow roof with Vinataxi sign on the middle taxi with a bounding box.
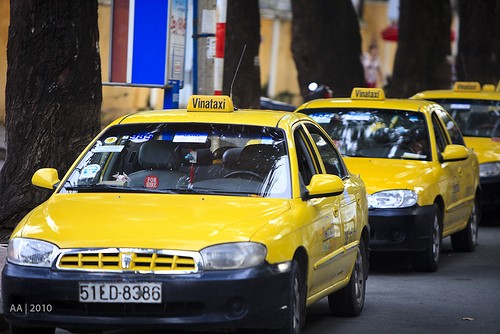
[297,87,436,113]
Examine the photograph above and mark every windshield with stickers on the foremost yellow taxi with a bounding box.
[61,123,291,198]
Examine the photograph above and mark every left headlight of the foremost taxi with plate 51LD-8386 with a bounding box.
[7,238,59,267]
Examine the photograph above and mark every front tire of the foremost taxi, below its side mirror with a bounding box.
[277,260,306,334]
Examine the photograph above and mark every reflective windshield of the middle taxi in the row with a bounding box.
[301,108,431,160]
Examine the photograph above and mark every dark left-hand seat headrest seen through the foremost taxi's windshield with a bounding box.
[138,140,181,170]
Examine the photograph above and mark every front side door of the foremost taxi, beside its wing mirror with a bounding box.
[294,125,344,296]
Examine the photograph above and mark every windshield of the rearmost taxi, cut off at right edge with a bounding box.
[434,99,500,138]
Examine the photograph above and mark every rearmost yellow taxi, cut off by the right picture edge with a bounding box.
[412,82,500,214]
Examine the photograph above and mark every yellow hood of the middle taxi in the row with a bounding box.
[344,157,432,194]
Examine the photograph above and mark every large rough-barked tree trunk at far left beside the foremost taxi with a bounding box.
[0,0,102,227]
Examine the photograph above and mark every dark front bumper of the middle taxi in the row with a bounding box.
[368,205,434,251]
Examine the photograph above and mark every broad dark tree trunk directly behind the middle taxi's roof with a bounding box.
[292,0,365,97]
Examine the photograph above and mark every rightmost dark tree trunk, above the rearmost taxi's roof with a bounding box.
[456,0,500,84]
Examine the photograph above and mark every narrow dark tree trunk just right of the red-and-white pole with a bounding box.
[222,0,262,108]
